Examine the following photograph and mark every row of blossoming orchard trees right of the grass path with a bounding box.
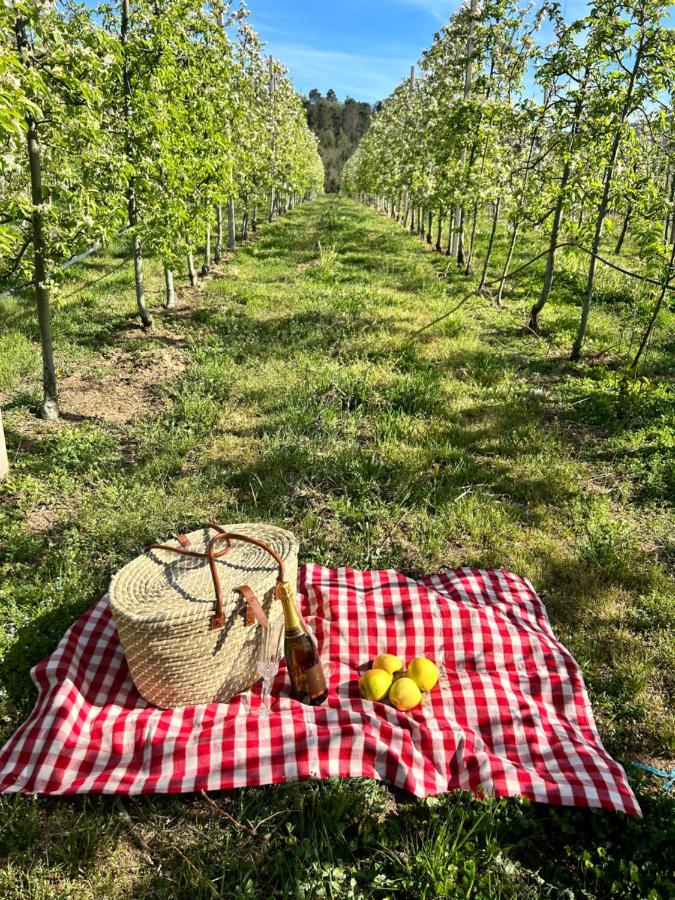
[344,0,675,369]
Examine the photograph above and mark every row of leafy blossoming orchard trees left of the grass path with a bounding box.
[0,0,323,418]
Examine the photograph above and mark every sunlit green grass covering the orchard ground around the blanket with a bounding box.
[0,197,675,898]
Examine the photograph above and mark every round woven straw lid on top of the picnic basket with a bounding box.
[109,522,298,624]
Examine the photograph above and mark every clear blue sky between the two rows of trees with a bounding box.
[248,0,586,103]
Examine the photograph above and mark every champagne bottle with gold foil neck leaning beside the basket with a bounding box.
[277,581,328,706]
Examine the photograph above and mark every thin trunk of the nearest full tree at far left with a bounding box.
[15,18,59,419]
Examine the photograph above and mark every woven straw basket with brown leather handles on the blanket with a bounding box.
[110,523,298,708]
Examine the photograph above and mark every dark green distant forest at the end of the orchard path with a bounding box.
[303,88,373,193]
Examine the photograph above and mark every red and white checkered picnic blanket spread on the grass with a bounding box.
[0,565,640,815]
